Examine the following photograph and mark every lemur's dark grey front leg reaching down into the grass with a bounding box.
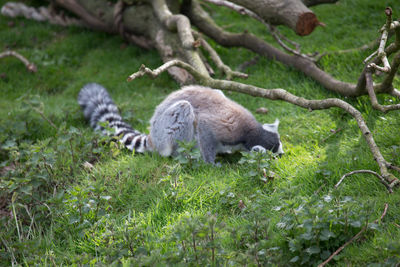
[197,121,218,163]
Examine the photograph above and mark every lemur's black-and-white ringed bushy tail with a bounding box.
[78,83,152,152]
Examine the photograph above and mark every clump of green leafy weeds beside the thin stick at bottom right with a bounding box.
[275,195,379,265]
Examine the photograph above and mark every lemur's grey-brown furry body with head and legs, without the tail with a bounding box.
[150,86,283,162]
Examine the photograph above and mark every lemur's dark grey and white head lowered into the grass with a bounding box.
[251,119,284,156]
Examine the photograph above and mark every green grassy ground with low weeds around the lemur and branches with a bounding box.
[0,0,400,266]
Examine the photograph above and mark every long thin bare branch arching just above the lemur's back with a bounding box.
[128,60,399,188]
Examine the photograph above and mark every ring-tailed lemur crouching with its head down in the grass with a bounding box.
[78,83,283,163]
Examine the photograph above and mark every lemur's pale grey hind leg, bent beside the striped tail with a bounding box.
[150,100,195,156]
